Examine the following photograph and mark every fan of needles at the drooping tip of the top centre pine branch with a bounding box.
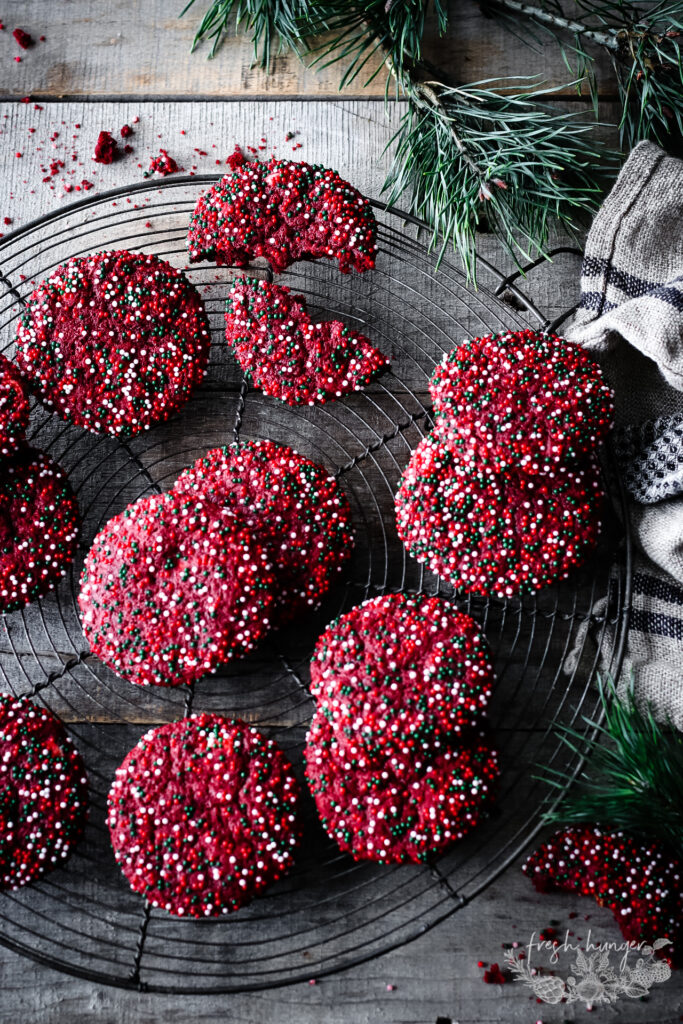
[384,80,616,273]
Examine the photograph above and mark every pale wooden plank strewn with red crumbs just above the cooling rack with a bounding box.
[0,100,401,233]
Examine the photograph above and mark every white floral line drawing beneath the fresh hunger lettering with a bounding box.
[506,936,671,1010]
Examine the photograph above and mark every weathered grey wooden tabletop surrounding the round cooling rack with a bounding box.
[0,0,682,1024]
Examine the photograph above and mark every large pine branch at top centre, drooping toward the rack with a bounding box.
[180,0,617,278]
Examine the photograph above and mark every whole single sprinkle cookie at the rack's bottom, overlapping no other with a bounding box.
[106,714,300,918]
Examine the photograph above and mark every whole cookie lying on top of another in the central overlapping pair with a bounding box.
[79,494,274,686]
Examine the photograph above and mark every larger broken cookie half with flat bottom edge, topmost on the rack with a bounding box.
[187,152,377,273]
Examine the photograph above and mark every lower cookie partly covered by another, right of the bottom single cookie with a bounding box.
[304,710,498,864]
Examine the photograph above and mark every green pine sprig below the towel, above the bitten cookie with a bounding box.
[542,680,683,855]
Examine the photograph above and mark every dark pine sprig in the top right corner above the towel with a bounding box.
[484,0,683,148]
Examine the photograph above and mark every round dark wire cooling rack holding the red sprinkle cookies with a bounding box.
[0,175,631,993]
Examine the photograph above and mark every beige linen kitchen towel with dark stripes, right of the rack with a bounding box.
[565,142,683,728]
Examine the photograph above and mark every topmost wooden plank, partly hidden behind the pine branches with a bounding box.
[0,0,614,99]
